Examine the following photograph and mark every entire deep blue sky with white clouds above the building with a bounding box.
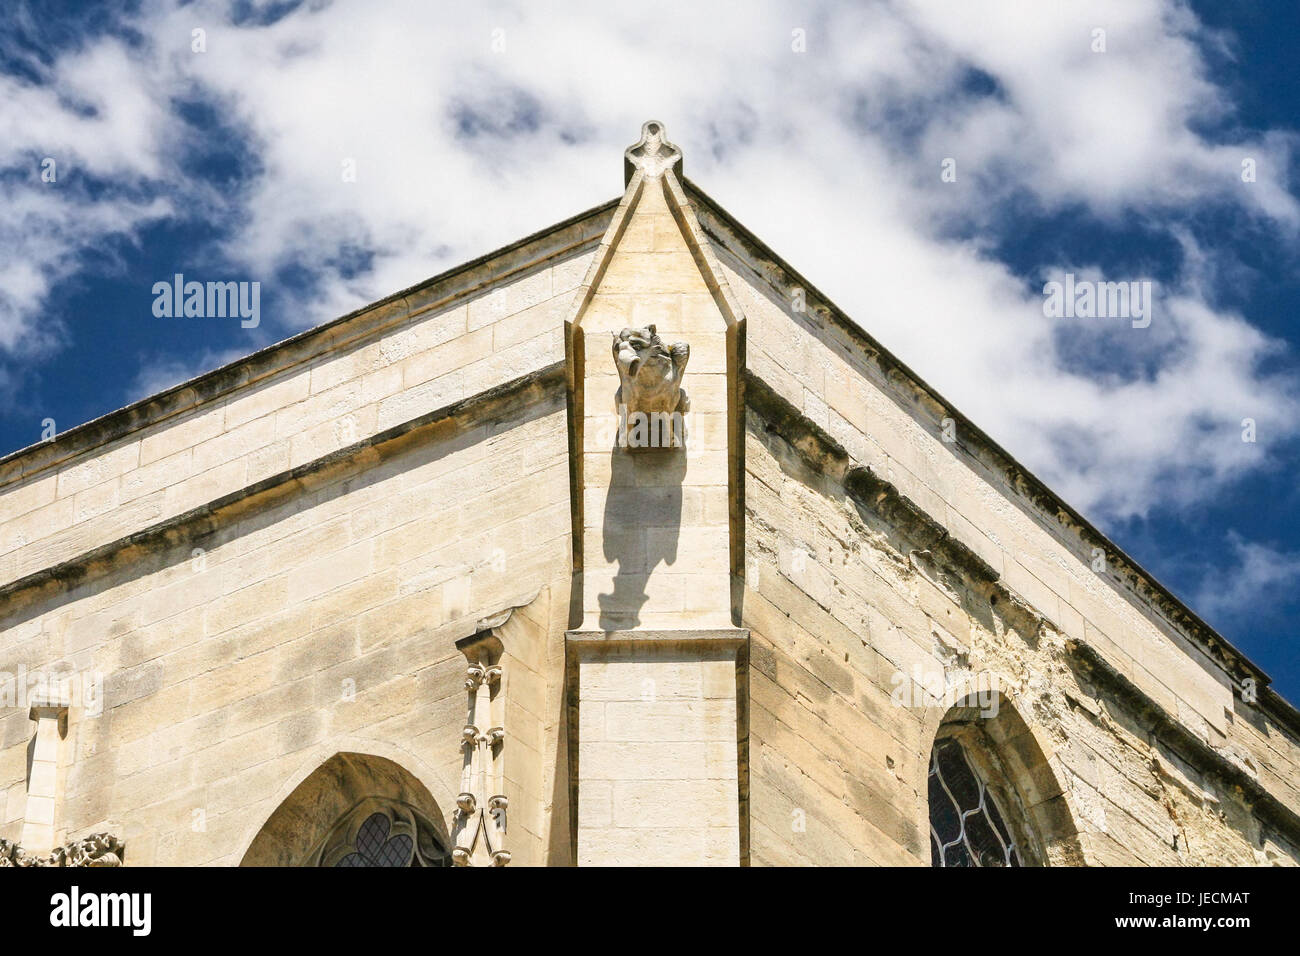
[0,0,1300,701]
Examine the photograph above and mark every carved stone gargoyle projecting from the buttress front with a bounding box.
[614,325,690,447]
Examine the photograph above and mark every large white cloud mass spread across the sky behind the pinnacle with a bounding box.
[0,0,1300,519]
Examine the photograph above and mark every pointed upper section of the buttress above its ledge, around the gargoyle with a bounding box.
[567,121,744,630]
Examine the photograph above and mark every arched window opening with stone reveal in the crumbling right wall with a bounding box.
[928,724,1040,866]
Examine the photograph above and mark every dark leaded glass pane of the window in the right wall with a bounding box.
[930,737,1023,866]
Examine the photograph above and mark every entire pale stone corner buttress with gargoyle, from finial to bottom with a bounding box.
[566,122,748,865]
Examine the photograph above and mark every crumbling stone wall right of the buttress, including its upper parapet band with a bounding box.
[706,221,1300,864]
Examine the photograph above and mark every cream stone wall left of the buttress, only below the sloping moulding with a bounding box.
[0,389,569,864]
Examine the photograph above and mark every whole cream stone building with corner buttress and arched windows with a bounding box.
[0,122,1300,866]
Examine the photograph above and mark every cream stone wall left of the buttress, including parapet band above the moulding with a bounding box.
[0,239,589,864]
